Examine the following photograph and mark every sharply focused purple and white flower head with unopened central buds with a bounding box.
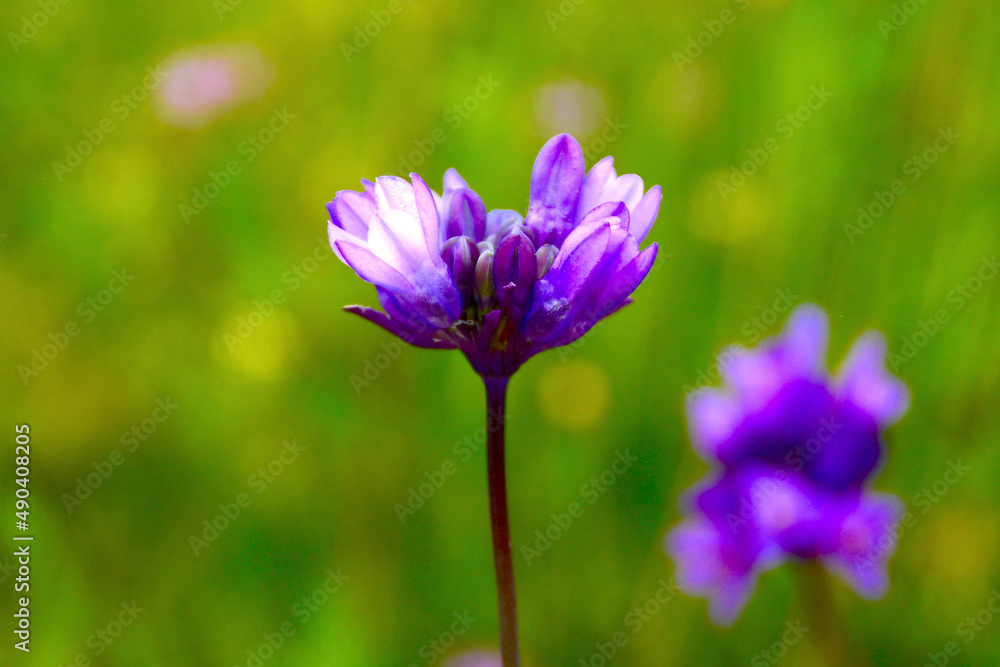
[327,134,660,378]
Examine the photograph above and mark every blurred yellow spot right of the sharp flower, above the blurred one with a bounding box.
[689,167,771,243]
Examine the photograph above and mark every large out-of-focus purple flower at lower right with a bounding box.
[666,305,909,625]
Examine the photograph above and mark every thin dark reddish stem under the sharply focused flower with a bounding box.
[483,378,520,667]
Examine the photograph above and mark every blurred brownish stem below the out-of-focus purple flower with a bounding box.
[798,560,871,667]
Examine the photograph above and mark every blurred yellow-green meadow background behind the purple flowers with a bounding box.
[0,0,1000,667]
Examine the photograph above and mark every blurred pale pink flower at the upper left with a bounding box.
[156,44,274,129]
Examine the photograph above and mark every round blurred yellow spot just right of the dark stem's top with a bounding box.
[537,359,609,431]
